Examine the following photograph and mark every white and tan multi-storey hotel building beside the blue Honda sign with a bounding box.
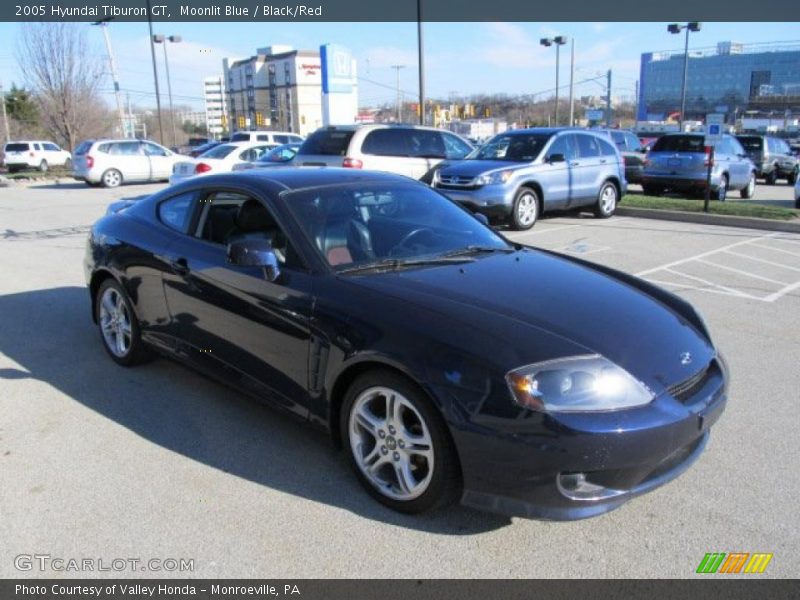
[222,46,322,135]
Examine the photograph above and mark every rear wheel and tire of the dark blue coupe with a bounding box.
[95,279,151,367]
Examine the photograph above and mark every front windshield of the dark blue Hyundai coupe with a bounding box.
[282,182,514,271]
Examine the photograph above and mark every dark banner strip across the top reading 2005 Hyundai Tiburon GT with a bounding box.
[0,0,797,22]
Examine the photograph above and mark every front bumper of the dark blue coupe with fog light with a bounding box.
[453,356,727,521]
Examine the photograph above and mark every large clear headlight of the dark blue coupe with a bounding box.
[506,354,655,412]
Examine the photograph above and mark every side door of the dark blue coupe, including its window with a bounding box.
[164,188,312,416]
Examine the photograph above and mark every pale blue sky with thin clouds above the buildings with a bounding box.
[0,23,800,109]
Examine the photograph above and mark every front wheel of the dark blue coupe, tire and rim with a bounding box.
[339,370,461,514]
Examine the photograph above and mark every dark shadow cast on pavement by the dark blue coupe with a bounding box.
[0,287,510,535]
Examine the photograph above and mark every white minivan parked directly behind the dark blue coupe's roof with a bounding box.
[292,125,474,178]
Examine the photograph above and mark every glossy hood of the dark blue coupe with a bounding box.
[352,250,715,393]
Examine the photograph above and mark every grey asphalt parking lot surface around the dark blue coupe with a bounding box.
[0,184,800,578]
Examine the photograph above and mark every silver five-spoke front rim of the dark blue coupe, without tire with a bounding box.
[350,387,434,501]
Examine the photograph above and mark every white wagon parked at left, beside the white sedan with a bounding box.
[72,139,186,187]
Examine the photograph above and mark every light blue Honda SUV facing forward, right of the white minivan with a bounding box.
[432,128,628,230]
